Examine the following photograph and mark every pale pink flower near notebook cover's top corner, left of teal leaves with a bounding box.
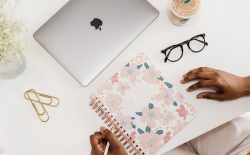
[120,63,140,82]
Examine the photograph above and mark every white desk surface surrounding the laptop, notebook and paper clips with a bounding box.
[0,0,250,155]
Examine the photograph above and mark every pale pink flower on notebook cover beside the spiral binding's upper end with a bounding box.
[106,93,122,112]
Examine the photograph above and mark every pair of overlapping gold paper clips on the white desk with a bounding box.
[24,89,59,122]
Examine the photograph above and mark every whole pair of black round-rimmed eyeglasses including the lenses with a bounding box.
[161,33,208,62]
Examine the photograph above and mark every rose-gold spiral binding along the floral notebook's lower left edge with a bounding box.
[89,97,145,155]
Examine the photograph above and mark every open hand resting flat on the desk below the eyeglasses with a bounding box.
[181,67,250,101]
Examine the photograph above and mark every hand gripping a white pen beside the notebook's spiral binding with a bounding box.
[90,127,127,155]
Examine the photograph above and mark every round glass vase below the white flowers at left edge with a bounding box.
[0,53,26,79]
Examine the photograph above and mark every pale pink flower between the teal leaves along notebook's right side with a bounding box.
[153,88,174,106]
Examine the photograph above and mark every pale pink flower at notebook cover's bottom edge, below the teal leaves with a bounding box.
[139,132,163,155]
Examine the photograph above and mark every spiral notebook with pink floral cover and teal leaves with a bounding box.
[90,54,196,155]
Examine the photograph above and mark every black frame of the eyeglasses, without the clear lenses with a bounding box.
[161,33,208,63]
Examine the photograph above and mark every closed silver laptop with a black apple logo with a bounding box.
[34,0,159,86]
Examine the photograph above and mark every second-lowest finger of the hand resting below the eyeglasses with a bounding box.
[187,80,220,92]
